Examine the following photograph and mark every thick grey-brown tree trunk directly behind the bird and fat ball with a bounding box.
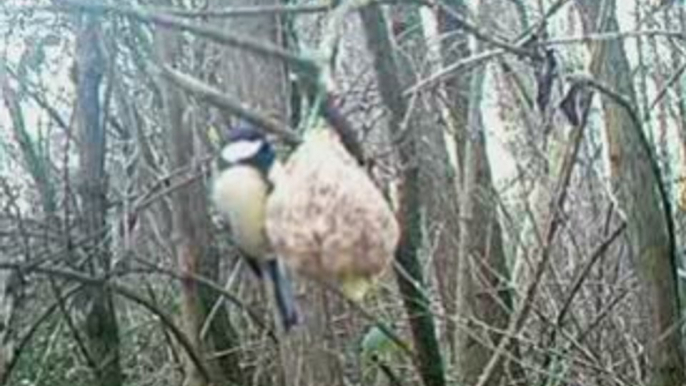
[215,0,332,386]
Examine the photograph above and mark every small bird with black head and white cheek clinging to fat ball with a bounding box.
[211,122,299,331]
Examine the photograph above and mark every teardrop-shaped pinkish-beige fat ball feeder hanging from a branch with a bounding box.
[265,121,400,301]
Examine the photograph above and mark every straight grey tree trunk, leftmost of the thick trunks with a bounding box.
[76,17,123,386]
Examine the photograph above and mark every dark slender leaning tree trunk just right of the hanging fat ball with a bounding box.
[360,5,445,386]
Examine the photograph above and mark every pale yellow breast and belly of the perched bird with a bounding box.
[212,166,270,259]
